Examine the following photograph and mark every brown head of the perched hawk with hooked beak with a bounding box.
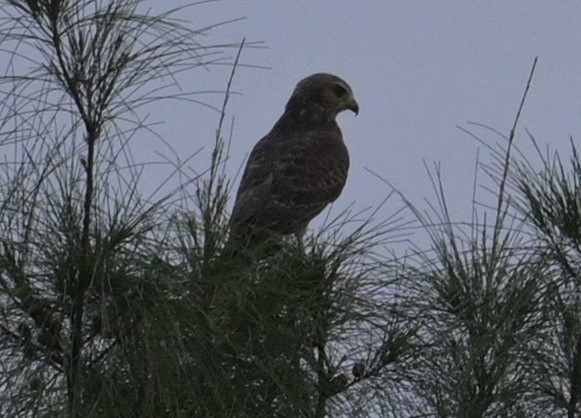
[286,73,359,119]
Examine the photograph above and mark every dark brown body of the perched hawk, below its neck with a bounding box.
[232,125,349,238]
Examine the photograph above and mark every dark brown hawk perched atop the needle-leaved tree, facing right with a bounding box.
[231,73,359,247]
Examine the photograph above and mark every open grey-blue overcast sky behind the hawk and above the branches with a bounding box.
[125,0,581,245]
